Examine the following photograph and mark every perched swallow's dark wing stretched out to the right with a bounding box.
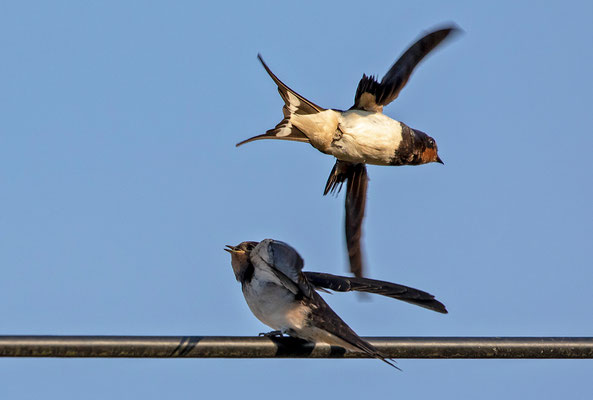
[304,272,447,314]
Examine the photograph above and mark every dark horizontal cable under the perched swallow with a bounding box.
[0,336,593,358]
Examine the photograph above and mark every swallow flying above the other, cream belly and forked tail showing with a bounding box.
[237,26,459,277]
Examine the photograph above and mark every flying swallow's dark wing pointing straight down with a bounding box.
[323,160,368,277]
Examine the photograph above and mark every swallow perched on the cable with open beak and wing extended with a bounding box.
[225,239,447,368]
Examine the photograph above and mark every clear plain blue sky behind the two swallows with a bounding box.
[0,1,593,399]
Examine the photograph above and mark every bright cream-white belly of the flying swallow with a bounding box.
[330,110,402,165]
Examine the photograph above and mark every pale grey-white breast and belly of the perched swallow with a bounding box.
[243,276,310,332]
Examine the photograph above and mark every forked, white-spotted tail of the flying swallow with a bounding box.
[237,54,325,147]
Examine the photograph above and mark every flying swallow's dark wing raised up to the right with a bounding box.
[352,26,459,112]
